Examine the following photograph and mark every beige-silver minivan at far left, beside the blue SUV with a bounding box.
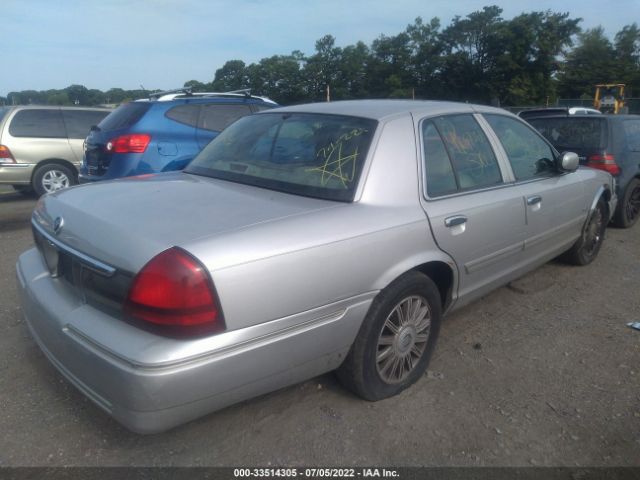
[0,105,111,195]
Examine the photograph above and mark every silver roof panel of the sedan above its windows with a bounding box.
[269,100,510,120]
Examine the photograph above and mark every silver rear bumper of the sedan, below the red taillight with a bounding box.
[16,249,373,433]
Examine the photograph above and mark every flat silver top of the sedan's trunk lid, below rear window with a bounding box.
[34,172,340,273]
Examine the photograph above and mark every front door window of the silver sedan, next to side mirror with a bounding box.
[484,114,557,180]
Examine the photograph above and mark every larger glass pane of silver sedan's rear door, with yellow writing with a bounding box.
[433,115,502,190]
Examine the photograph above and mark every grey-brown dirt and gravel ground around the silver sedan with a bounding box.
[0,187,640,466]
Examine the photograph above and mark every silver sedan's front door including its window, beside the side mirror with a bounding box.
[484,114,587,261]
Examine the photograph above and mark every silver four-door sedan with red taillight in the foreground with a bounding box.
[17,101,616,433]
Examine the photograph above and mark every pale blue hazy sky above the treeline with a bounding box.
[0,0,640,96]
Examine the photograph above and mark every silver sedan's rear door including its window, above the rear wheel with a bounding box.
[420,114,525,303]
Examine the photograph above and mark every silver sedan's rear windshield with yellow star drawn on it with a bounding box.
[185,112,377,202]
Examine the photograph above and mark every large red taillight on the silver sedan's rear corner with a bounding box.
[125,247,225,332]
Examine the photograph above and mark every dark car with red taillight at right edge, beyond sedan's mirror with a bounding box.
[526,113,640,228]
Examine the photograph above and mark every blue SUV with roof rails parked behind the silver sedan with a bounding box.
[78,89,278,183]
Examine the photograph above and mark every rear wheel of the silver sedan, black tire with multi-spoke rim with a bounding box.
[337,272,442,401]
